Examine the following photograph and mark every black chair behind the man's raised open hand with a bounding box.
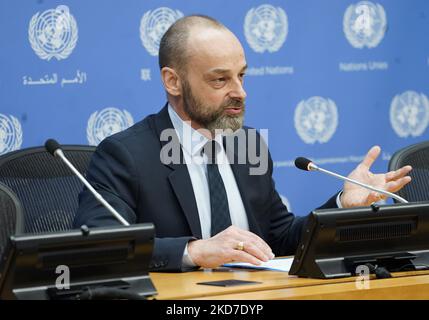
[389,141,429,202]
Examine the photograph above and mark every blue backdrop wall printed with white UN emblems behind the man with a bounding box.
[0,0,429,215]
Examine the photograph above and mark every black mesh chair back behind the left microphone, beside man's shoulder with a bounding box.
[0,145,95,233]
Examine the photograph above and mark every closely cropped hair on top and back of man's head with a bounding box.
[159,15,230,72]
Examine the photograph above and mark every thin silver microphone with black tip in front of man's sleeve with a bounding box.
[45,139,130,226]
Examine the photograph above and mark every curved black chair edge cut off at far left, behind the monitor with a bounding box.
[0,183,24,261]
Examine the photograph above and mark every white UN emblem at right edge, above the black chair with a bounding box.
[390,91,429,138]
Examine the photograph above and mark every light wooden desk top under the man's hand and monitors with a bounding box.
[151,269,429,300]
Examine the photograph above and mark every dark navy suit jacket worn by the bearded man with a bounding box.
[74,107,336,271]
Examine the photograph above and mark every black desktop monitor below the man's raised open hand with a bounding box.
[289,202,429,278]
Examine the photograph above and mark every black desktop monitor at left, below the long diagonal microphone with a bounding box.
[0,223,156,300]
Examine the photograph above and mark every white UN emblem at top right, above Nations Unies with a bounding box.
[343,1,387,49]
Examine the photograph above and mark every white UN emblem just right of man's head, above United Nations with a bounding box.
[244,4,288,53]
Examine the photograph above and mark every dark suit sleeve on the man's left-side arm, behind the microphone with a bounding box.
[73,137,193,271]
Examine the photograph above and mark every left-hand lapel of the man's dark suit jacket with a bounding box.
[155,105,202,238]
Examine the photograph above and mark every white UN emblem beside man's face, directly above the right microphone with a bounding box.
[294,97,338,144]
